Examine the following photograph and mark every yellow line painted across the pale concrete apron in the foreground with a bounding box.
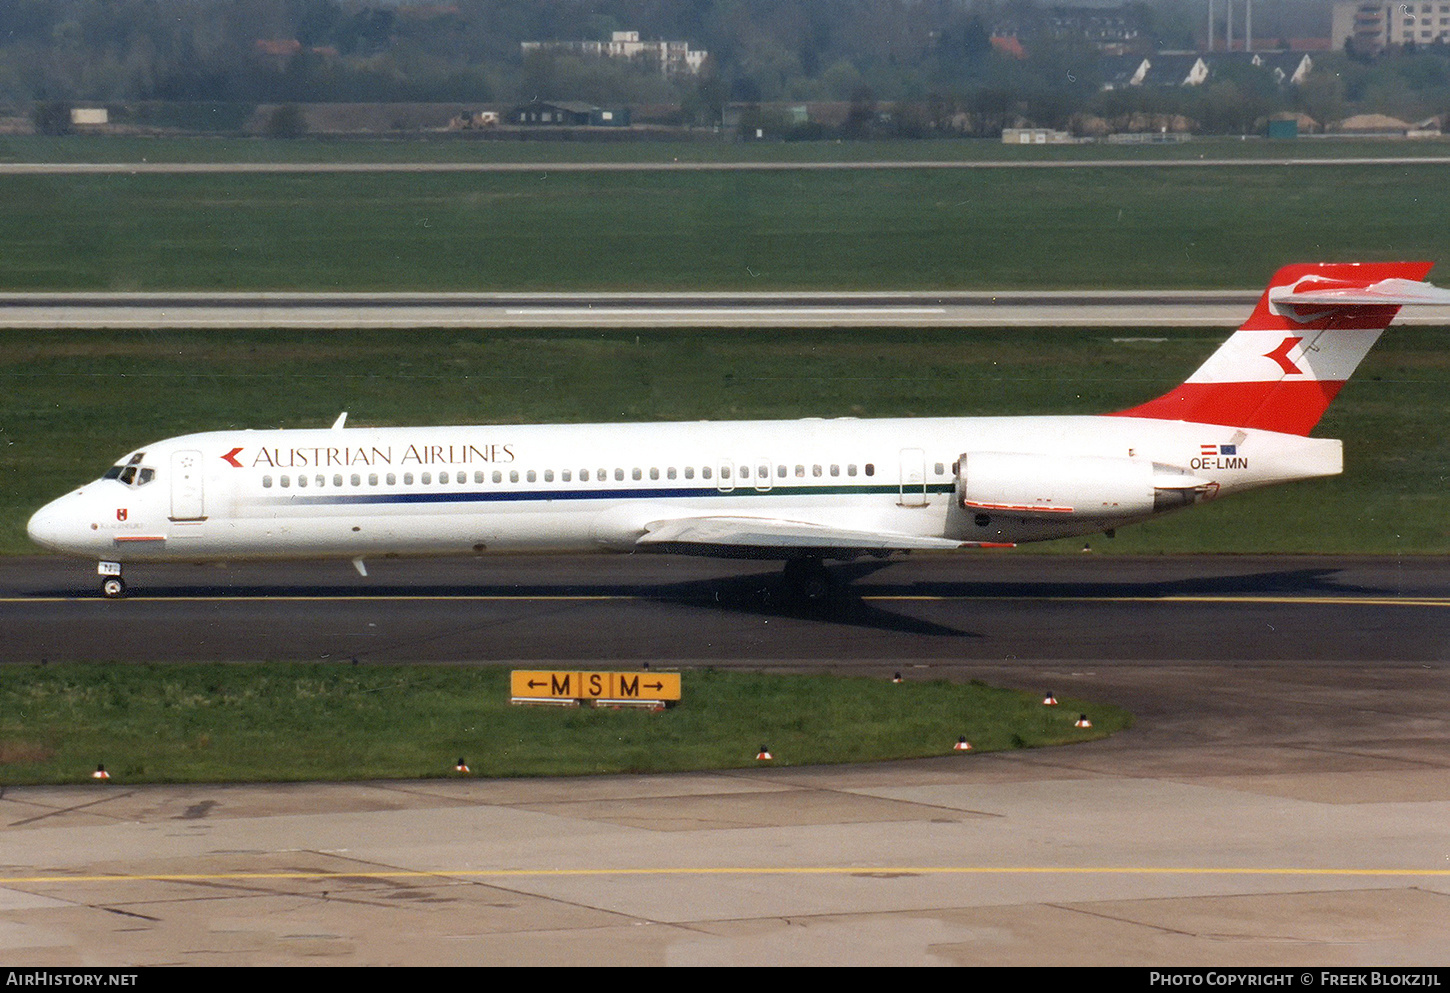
[0,865,1450,886]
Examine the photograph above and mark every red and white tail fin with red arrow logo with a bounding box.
[1118,262,1450,435]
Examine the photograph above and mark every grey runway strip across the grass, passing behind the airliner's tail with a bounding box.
[0,290,1446,331]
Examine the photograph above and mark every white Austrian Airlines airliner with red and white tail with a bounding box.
[29,262,1450,597]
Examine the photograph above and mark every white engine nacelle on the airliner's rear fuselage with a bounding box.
[957,452,1214,519]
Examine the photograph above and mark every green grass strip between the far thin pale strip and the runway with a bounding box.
[0,165,1450,290]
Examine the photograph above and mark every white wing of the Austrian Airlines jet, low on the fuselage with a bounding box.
[635,518,1012,551]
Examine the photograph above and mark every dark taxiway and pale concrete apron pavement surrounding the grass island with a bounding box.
[0,552,1450,965]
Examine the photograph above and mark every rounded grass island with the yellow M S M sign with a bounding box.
[0,662,1131,784]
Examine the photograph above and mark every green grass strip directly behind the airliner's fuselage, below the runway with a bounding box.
[0,328,1450,554]
